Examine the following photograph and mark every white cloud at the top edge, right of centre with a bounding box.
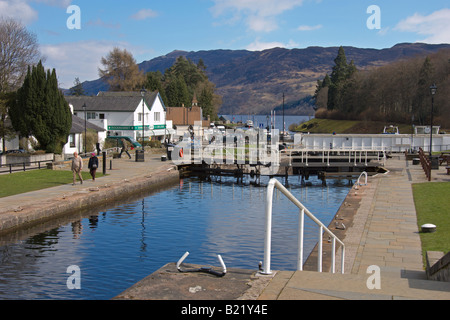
[211,0,304,32]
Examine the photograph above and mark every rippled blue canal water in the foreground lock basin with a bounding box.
[0,177,350,300]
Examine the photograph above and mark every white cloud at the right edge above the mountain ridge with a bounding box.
[394,9,450,44]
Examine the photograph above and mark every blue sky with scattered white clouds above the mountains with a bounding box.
[0,0,450,88]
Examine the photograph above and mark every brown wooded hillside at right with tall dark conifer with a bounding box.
[315,48,450,127]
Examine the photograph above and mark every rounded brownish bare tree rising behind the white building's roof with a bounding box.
[98,47,145,91]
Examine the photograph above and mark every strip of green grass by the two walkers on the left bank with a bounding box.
[0,169,103,198]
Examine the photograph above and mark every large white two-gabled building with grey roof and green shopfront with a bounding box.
[66,92,174,140]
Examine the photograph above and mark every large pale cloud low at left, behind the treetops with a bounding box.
[41,40,130,89]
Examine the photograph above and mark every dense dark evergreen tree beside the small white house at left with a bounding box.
[9,61,72,153]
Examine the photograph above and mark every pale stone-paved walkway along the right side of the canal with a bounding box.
[259,155,450,300]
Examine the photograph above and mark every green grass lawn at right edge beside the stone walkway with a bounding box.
[413,182,450,256]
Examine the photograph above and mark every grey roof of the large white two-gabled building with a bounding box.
[65,91,165,112]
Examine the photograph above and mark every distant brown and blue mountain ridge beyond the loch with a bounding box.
[79,43,450,114]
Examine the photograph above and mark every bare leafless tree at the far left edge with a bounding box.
[0,18,40,150]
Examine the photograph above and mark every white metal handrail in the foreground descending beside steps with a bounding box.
[261,179,345,274]
